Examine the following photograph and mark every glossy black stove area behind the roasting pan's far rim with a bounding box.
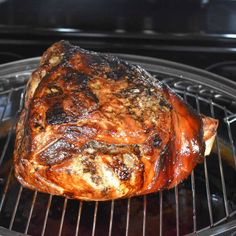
[0,0,236,79]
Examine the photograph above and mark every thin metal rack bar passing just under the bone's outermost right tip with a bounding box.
[210,102,229,217]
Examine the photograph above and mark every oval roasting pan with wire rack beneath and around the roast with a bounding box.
[0,55,236,235]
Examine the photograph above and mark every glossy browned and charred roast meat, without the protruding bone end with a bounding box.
[14,41,217,200]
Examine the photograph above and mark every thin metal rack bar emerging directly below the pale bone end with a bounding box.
[196,96,213,226]
